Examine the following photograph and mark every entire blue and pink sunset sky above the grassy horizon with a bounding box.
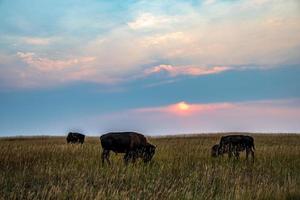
[0,0,300,136]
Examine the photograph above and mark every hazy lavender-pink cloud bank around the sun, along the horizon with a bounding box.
[95,99,300,135]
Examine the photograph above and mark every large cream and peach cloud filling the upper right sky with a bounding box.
[96,1,300,76]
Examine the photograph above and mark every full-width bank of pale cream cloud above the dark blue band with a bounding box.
[0,0,300,89]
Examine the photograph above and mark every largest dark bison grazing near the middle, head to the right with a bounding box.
[100,132,155,164]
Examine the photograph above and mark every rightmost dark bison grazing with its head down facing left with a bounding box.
[211,135,255,160]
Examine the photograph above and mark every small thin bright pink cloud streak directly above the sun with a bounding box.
[144,65,231,77]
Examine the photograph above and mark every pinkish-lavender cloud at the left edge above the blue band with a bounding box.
[0,52,115,89]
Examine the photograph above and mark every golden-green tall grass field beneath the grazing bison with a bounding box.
[0,135,300,199]
